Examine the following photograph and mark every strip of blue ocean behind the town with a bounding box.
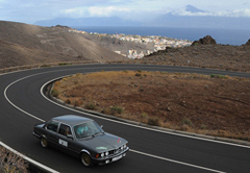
[74,26,250,45]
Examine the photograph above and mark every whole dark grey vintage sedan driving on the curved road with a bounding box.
[33,115,129,166]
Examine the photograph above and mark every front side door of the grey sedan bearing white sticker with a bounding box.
[57,123,77,155]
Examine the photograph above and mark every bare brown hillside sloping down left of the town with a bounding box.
[0,21,126,68]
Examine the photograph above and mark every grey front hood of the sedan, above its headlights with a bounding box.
[79,133,127,152]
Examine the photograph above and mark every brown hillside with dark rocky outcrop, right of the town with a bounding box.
[133,36,250,72]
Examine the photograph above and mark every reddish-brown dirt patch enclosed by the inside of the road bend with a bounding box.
[53,71,250,140]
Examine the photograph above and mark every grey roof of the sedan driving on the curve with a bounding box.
[52,115,93,126]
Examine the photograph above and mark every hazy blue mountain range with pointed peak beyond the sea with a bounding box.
[34,5,250,29]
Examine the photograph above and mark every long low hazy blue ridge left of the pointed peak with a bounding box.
[34,17,142,26]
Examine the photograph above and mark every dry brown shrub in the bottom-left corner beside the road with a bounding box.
[0,146,29,173]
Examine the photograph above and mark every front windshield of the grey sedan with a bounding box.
[73,121,103,139]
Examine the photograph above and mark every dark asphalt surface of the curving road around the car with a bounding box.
[0,65,250,173]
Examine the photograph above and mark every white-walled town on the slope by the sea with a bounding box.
[69,29,193,59]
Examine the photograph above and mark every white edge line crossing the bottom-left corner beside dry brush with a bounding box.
[0,141,59,173]
